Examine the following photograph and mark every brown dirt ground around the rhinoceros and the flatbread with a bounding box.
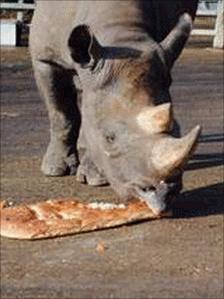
[1,48,224,299]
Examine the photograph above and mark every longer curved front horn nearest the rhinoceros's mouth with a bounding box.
[152,126,201,176]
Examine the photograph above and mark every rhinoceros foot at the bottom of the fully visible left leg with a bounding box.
[41,144,78,176]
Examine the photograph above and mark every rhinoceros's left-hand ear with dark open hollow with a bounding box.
[68,25,102,68]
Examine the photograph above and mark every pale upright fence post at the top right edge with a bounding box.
[213,0,224,49]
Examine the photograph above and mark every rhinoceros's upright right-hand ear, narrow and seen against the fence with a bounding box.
[160,13,193,67]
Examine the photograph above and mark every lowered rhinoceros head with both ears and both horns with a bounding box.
[69,15,200,214]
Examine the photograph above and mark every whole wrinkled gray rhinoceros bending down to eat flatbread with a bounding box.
[30,0,199,214]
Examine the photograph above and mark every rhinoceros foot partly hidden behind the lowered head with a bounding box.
[76,157,108,186]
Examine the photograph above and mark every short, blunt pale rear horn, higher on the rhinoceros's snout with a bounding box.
[136,103,172,134]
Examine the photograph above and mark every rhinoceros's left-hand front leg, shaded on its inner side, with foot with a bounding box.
[33,61,80,176]
